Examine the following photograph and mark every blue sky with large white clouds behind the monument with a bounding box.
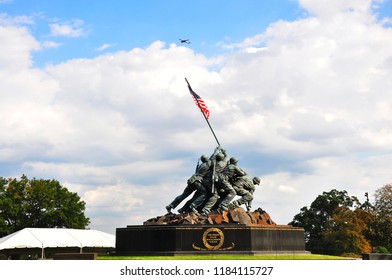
[0,0,392,234]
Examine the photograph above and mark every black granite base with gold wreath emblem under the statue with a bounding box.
[116,225,309,256]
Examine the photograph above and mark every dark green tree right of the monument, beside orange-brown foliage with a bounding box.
[289,189,360,254]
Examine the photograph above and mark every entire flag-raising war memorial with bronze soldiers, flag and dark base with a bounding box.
[115,79,309,256]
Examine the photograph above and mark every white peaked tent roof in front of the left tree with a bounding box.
[0,228,116,250]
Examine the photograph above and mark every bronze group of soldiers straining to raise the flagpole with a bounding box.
[166,146,260,215]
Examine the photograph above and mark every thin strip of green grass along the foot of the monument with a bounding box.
[98,254,352,260]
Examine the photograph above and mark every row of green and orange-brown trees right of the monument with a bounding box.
[289,185,392,256]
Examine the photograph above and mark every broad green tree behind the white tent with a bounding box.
[0,175,90,237]
